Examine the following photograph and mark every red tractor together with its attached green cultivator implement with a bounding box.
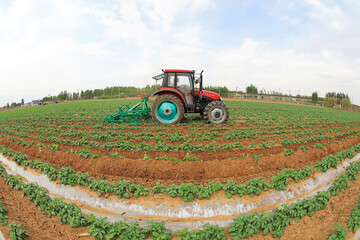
[104,69,229,124]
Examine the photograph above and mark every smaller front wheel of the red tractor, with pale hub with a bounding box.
[203,100,229,124]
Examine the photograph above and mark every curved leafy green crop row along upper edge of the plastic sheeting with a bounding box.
[0,144,360,202]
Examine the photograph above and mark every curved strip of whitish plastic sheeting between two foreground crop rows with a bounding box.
[0,154,360,230]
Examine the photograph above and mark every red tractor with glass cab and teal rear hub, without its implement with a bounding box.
[150,69,229,124]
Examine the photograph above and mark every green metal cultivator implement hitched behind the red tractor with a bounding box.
[104,96,150,123]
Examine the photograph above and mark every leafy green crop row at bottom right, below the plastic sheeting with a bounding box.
[228,159,360,239]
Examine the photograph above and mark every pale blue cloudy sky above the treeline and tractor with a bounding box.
[0,0,360,106]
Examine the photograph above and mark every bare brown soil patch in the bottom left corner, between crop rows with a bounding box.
[0,174,94,240]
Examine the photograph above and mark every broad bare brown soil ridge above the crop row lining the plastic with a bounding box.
[0,134,360,186]
